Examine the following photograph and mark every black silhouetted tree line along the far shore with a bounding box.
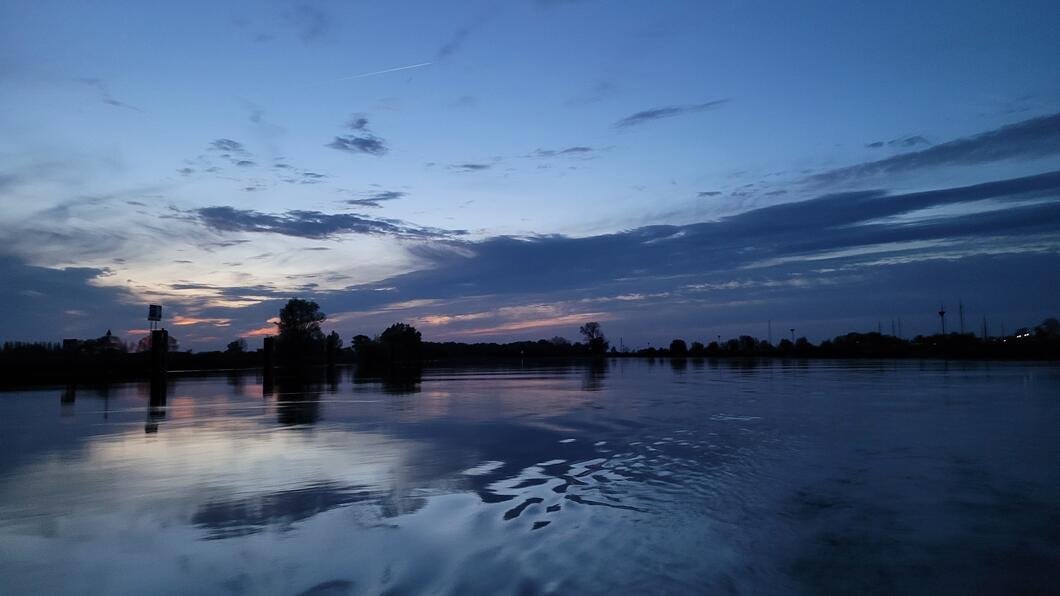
[0,298,1060,384]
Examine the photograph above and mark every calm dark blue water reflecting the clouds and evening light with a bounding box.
[0,360,1060,595]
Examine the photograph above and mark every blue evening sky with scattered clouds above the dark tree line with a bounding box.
[0,0,1060,350]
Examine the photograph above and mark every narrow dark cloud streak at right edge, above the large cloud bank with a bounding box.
[807,113,1060,186]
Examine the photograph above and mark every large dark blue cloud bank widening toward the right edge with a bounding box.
[309,172,1060,341]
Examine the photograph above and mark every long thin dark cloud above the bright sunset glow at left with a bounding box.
[189,206,464,240]
